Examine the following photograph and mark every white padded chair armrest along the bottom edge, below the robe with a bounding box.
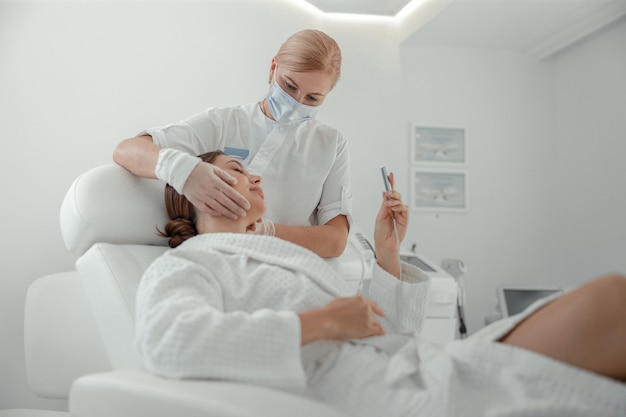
[69,371,346,417]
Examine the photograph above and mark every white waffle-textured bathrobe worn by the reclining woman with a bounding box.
[136,234,626,417]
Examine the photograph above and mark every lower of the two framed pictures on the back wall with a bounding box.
[410,168,469,212]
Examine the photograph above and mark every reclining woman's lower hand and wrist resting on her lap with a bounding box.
[299,295,385,345]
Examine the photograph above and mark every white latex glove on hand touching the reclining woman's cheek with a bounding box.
[155,149,250,219]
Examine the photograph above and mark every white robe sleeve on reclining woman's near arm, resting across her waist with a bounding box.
[136,250,306,391]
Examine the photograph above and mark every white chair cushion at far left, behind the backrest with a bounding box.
[24,271,111,398]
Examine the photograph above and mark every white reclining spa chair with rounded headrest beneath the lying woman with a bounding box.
[61,164,345,417]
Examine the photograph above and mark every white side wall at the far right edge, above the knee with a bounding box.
[554,19,626,281]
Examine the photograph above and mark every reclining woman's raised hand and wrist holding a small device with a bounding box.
[374,173,409,277]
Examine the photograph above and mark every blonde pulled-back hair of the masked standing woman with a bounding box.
[275,29,341,88]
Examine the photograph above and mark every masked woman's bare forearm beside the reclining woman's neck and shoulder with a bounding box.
[275,215,349,258]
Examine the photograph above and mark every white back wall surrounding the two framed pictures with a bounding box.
[402,46,556,330]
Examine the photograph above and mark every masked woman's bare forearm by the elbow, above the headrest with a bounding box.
[113,135,160,178]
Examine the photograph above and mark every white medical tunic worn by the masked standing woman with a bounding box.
[141,103,352,226]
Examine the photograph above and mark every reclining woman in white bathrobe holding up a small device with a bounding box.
[136,152,626,417]
